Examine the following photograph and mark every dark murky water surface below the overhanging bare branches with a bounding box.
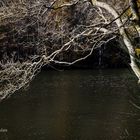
[0,69,140,140]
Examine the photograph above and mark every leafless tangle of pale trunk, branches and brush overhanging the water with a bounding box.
[0,0,140,99]
